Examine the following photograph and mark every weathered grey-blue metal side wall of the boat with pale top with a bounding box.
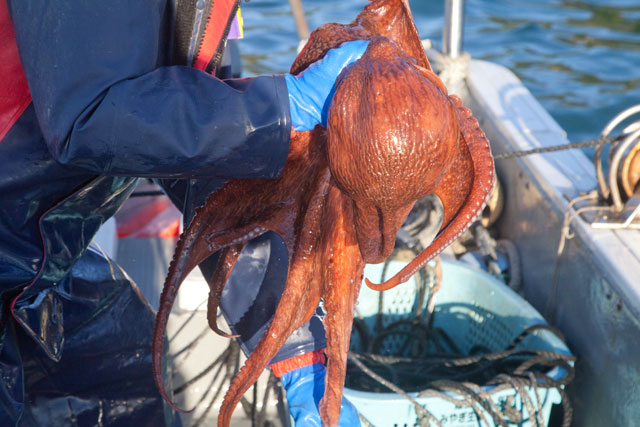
[444,2,640,427]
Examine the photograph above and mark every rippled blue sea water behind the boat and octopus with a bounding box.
[241,0,640,145]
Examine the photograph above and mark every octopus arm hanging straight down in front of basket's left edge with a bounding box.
[319,185,364,426]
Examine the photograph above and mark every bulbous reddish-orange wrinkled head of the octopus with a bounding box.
[327,39,460,263]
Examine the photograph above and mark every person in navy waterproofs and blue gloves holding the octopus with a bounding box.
[0,0,366,426]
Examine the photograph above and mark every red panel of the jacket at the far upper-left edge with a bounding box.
[0,0,31,141]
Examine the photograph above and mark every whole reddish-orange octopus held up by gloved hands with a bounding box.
[152,0,494,426]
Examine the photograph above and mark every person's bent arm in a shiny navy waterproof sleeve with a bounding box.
[9,0,291,178]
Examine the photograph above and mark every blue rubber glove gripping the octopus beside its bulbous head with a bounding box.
[284,40,369,131]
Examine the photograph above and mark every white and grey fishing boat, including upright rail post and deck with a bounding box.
[95,0,640,427]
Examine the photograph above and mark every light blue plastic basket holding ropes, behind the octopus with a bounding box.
[344,261,571,427]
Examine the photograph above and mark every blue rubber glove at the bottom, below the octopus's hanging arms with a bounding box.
[280,363,360,427]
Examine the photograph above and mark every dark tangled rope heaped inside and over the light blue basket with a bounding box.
[345,256,576,427]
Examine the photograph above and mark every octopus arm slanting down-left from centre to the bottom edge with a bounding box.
[218,169,330,427]
